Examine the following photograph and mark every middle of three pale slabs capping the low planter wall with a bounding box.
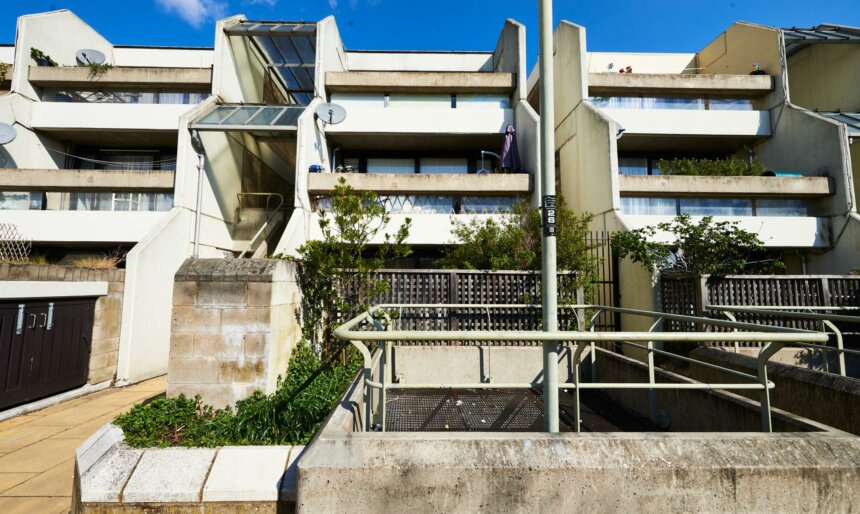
[123,448,216,503]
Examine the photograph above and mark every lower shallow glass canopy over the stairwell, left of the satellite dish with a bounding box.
[191,105,305,132]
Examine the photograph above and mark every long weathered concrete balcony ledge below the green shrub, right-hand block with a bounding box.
[618,175,833,198]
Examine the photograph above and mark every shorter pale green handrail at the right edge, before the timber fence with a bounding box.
[705,305,860,377]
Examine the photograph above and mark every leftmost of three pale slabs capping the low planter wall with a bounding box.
[81,443,144,503]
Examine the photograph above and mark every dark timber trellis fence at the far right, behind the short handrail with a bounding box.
[660,273,860,332]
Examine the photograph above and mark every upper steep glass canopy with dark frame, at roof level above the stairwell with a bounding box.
[225,21,317,105]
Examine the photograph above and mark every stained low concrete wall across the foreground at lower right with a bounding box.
[296,356,860,514]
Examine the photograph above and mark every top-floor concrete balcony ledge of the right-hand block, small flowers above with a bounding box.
[588,73,774,97]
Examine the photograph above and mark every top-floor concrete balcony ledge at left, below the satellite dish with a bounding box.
[28,66,212,90]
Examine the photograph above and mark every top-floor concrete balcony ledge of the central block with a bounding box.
[325,71,516,93]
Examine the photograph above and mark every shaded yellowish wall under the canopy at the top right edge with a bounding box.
[788,43,860,112]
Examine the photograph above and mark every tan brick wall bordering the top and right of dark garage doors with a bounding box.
[0,263,125,384]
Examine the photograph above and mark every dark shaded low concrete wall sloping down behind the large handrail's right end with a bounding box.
[688,348,860,435]
